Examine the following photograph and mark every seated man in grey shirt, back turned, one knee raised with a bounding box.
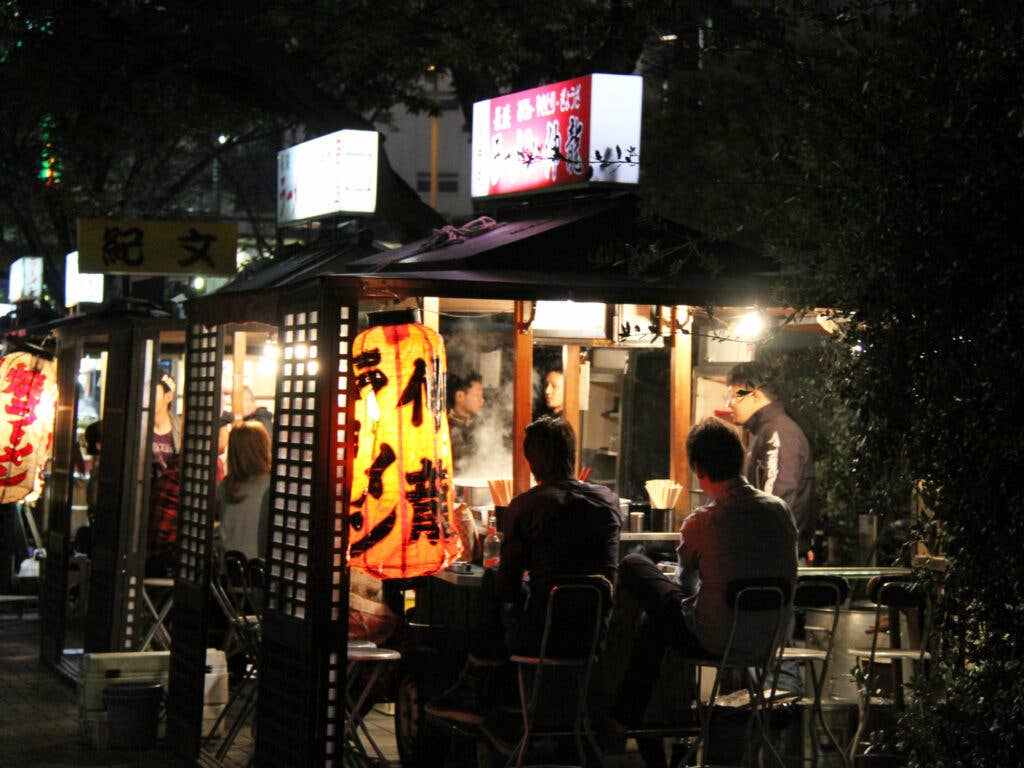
[612,418,797,766]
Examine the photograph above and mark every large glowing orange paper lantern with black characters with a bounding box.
[348,324,462,579]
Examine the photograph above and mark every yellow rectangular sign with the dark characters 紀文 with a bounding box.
[78,219,239,275]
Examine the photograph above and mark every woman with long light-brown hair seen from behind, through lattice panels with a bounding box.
[217,421,270,559]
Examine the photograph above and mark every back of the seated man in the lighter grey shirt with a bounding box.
[677,479,797,653]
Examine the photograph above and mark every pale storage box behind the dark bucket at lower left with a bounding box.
[78,650,171,749]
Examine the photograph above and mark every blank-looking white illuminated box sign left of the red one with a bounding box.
[278,130,378,226]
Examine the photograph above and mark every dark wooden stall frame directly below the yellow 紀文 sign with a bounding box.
[25,306,184,679]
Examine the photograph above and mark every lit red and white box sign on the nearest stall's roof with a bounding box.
[471,75,643,198]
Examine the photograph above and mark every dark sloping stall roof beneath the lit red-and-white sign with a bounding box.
[189,197,780,322]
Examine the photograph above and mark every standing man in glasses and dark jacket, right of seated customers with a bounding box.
[728,362,817,557]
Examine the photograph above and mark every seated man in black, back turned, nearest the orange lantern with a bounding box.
[426,417,622,724]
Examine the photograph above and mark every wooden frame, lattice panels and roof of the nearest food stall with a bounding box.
[161,183,782,765]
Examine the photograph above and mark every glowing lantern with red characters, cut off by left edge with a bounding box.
[0,352,57,504]
